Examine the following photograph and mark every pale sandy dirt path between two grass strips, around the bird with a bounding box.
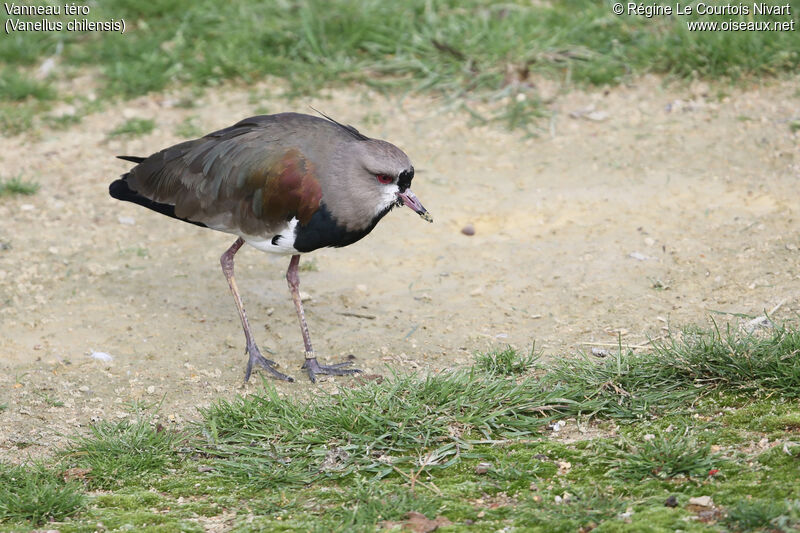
[0,78,800,461]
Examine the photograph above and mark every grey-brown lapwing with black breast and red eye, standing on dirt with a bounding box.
[109,110,433,383]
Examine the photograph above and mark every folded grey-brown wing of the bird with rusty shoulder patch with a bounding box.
[128,120,322,235]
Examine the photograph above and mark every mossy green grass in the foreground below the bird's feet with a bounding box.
[0,328,800,532]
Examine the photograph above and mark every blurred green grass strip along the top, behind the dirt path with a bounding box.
[0,0,800,134]
